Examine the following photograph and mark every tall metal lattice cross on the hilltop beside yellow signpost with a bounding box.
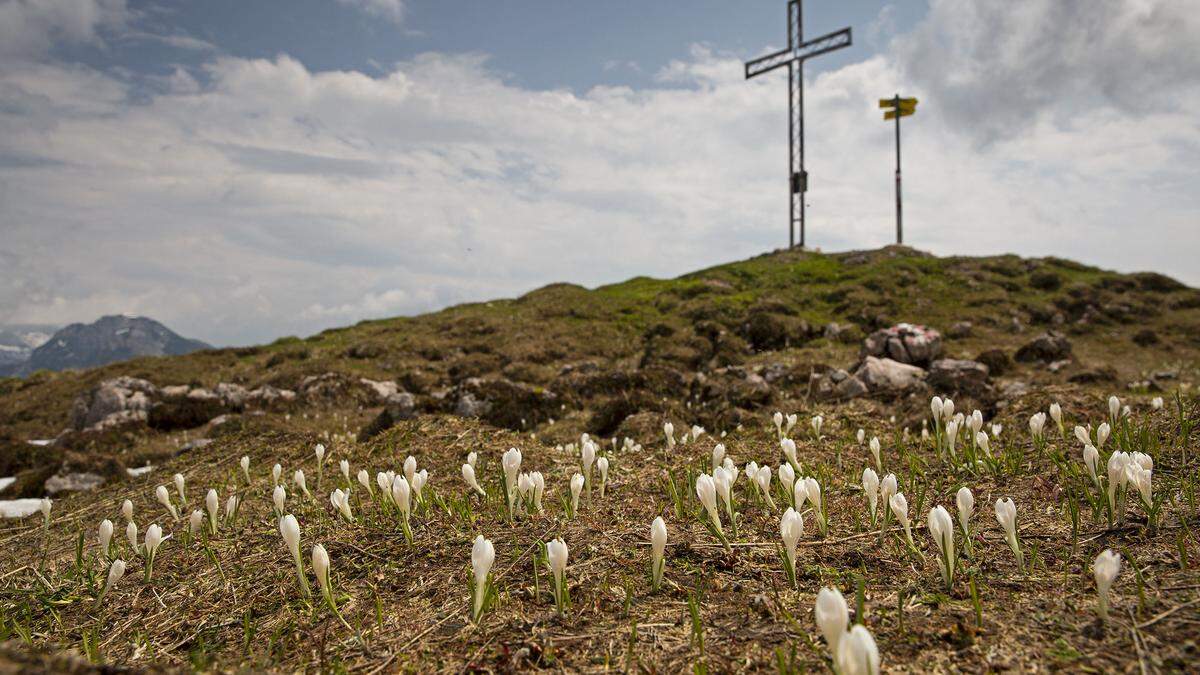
[746,0,851,249]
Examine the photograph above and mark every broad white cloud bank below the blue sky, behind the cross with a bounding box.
[0,0,1200,344]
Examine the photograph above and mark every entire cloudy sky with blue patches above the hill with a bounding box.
[0,0,1200,345]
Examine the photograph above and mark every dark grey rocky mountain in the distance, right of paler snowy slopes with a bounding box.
[0,316,211,375]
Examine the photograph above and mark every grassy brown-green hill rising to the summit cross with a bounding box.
[0,247,1200,671]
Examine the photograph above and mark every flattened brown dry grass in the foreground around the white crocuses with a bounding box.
[0,389,1200,673]
